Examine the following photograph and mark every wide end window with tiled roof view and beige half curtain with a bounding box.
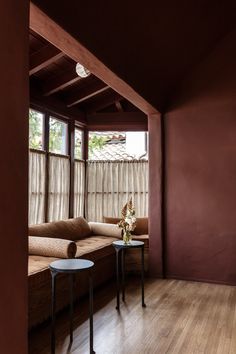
[86,131,148,222]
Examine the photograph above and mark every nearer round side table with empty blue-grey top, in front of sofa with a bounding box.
[49,259,95,354]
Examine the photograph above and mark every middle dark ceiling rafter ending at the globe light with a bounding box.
[42,70,81,96]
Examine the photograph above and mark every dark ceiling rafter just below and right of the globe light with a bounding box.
[65,81,109,107]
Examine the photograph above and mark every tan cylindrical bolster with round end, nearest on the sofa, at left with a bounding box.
[29,236,77,258]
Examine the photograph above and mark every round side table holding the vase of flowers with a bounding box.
[112,240,146,311]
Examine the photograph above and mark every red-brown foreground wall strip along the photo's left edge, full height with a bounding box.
[0,0,28,354]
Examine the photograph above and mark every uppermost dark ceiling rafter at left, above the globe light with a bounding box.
[29,45,64,75]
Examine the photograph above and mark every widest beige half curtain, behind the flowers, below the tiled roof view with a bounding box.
[86,161,148,221]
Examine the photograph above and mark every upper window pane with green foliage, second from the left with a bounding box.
[49,117,67,155]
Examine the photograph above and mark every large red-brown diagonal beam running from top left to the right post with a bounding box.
[30,2,158,114]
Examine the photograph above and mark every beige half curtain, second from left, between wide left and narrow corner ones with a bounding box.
[48,155,70,221]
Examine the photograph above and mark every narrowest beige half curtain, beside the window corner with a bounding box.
[74,161,85,217]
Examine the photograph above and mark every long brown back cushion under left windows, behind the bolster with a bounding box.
[29,216,91,241]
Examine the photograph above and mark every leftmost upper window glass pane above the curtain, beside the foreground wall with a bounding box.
[29,109,44,150]
